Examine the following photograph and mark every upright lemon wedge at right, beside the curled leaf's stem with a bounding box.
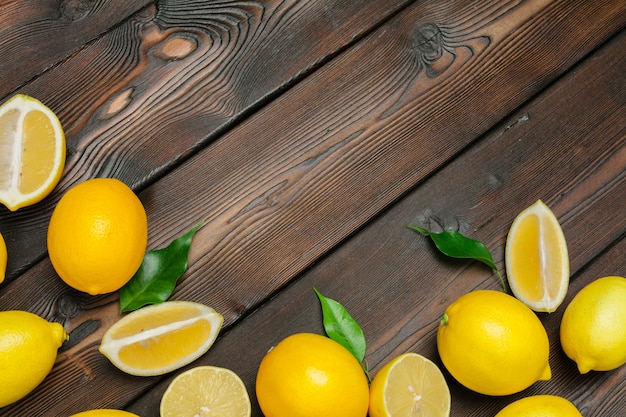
[505,200,569,312]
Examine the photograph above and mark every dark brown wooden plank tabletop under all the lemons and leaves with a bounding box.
[0,0,626,417]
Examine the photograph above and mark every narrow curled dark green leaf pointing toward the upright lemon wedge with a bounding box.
[407,224,506,290]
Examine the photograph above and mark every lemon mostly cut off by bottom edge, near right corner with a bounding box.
[495,395,583,417]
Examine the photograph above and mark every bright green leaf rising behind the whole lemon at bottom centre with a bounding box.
[313,288,365,363]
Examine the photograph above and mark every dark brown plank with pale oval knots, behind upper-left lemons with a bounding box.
[0,0,409,281]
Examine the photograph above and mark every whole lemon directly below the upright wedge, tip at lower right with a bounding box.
[437,290,551,395]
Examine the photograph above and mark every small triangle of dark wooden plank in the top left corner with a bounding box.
[0,0,151,97]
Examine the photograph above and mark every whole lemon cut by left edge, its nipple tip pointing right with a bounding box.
[0,310,67,407]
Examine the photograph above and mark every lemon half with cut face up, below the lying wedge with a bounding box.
[161,366,252,417]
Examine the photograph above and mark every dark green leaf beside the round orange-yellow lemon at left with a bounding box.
[120,223,203,313]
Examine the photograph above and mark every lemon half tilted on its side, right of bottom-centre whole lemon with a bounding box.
[369,352,450,417]
